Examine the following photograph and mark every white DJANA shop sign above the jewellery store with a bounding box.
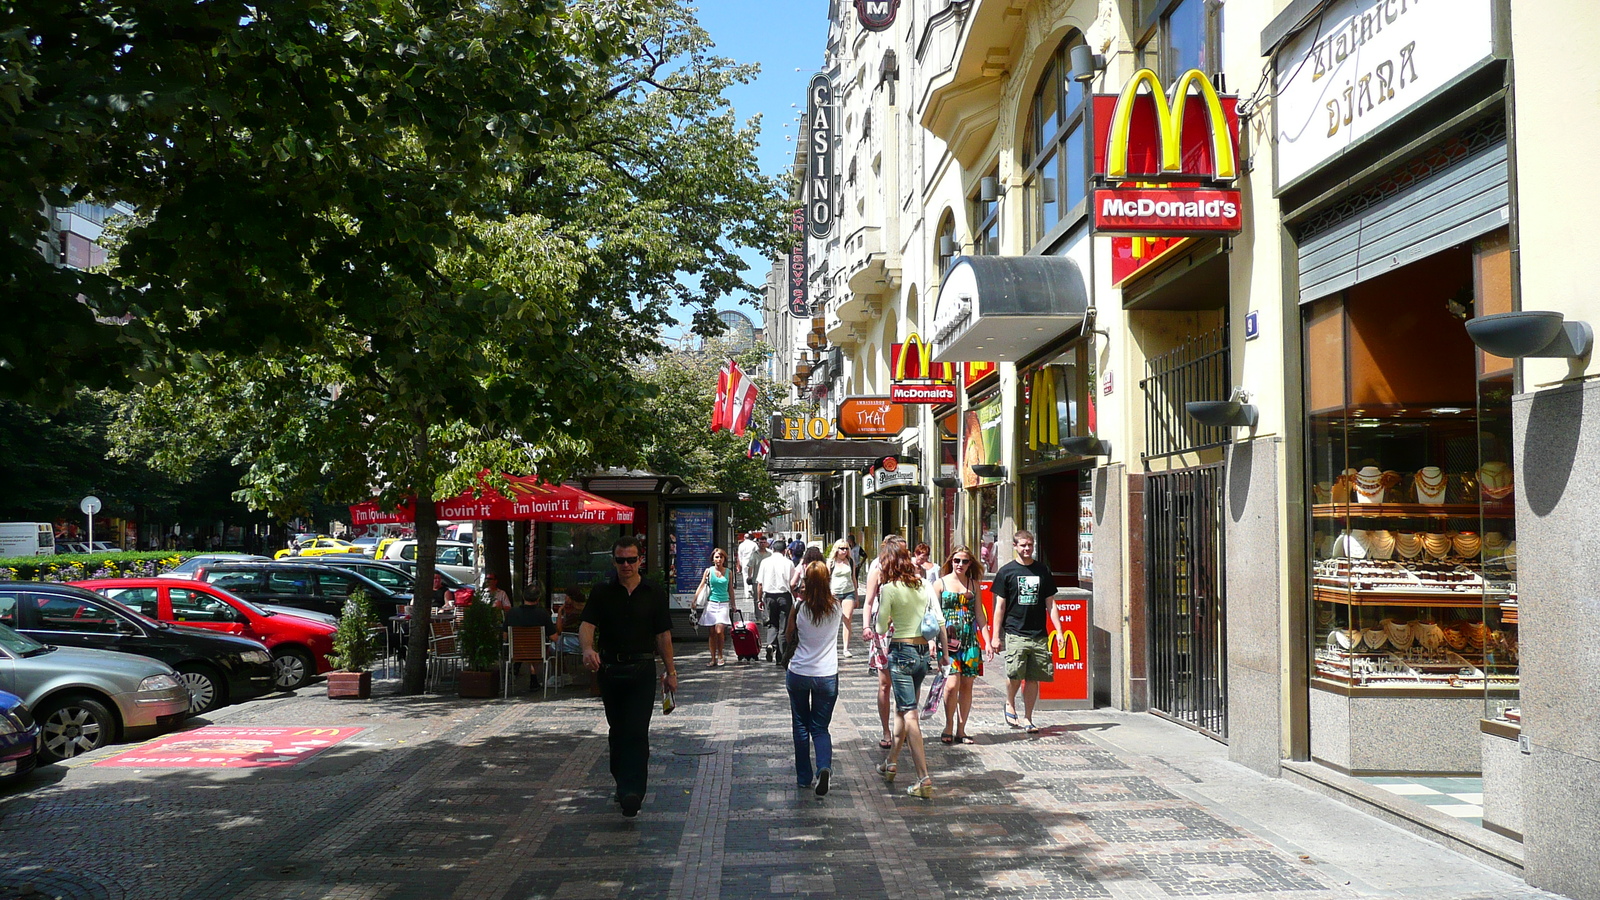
[1272,0,1496,191]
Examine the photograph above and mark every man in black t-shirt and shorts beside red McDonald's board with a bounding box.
[989,532,1061,735]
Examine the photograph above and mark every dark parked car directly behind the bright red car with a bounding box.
[195,560,411,618]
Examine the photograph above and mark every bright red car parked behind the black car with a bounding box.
[74,578,334,690]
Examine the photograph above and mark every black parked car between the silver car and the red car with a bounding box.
[0,581,275,716]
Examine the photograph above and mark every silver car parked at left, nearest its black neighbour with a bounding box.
[0,625,189,762]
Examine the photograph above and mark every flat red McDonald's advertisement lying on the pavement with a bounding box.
[94,725,363,769]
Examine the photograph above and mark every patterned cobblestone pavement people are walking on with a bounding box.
[0,637,1550,900]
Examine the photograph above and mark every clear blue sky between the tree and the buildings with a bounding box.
[659,0,827,341]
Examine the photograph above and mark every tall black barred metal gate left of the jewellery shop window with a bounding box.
[1144,463,1227,740]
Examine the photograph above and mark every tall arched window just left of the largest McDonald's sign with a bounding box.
[1022,32,1090,247]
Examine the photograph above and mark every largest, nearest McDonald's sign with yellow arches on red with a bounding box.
[1093,69,1243,237]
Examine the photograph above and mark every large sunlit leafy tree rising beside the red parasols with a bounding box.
[100,0,782,690]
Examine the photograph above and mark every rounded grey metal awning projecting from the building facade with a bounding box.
[933,256,1090,362]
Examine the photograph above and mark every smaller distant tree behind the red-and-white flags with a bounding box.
[638,340,794,532]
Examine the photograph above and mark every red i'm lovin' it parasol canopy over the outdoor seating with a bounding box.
[350,476,634,525]
